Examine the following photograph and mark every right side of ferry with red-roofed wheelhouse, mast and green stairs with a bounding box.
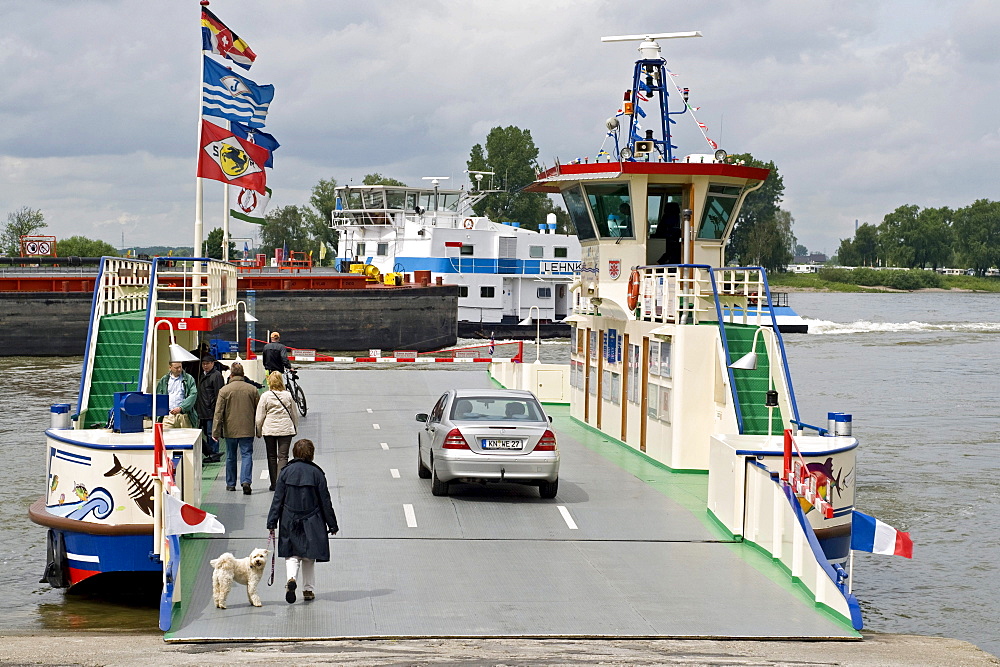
[493,32,861,628]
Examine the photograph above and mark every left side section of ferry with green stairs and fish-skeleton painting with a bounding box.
[28,257,238,589]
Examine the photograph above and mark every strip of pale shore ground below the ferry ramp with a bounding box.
[0,633,1000,667]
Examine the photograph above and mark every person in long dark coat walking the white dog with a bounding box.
[267,438,340,604]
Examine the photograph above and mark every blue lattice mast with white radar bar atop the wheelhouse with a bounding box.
[601,30,702,162]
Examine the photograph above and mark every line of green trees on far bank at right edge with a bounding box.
[836,204,1000,276]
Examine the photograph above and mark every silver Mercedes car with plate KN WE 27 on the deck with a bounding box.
[417,389,559,498]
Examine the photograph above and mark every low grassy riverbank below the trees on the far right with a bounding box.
[767,269,1000,292]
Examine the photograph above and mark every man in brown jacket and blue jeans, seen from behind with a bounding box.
[212,363,260,496]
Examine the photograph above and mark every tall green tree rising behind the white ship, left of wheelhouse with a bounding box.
[466,125,550,228]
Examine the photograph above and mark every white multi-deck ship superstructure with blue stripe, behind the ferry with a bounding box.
[331,177,581,338]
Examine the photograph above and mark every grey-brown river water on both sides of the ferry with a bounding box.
[0,292,1000,654]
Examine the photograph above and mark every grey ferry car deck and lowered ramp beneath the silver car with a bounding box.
[165,366,860,642]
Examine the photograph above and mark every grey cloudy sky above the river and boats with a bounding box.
[0,0,1000,253]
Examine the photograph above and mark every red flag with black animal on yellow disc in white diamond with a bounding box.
[198,121,270,194]
